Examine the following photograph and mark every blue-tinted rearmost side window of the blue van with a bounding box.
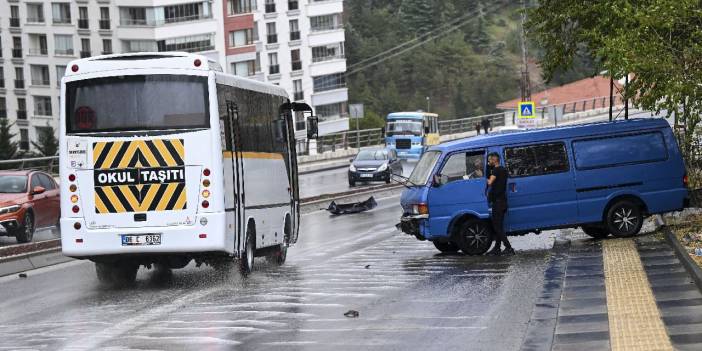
[573,132,668,169]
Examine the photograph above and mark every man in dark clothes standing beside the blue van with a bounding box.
[487,152,514,256]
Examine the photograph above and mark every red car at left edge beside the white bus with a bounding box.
[0,171,61,243]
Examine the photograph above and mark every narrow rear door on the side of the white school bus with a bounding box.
[223,100,246,253]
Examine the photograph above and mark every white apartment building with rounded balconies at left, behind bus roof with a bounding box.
[0,0,224,154]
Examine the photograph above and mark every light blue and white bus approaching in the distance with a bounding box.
[384,111,439,160]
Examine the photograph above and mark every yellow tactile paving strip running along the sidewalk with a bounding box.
[602,239,673,351]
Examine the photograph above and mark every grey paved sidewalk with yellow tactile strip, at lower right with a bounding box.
[522,234,702,350]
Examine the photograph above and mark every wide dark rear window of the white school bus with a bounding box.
[66,75,209,134]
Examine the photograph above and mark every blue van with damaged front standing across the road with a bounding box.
[398,119,688,255]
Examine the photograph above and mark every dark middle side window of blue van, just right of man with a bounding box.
[505,143,570,177]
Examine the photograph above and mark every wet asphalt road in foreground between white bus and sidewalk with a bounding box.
[0,196,553,350]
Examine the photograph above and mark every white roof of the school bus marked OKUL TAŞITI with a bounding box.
[66,52,288,98]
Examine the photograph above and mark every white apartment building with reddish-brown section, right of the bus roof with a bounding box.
[223,0,349,134]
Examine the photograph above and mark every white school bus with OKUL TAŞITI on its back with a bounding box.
[59,53,317,283]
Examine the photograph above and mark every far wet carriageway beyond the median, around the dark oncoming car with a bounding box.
[300,161,417,198]
